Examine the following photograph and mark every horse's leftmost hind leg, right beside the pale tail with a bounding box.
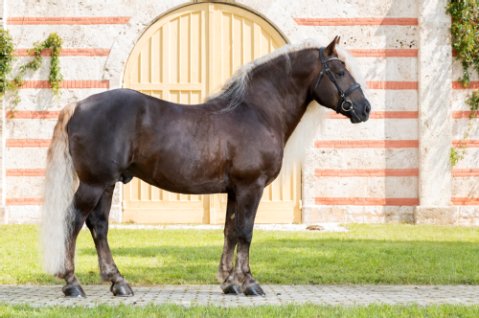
[58,183,103,297]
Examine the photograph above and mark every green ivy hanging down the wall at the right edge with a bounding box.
[447,0,479,166]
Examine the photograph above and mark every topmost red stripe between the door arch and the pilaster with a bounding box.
[294,17,419,26]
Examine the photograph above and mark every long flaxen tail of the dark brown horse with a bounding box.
[41,103,78,275]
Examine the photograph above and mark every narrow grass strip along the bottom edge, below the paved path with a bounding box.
[0,305,479,318]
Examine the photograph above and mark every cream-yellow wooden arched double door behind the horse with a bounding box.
[122,3,301,224]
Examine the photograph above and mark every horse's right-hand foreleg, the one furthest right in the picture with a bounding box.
[234,185,264,296]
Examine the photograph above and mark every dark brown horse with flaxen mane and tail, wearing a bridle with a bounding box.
[42,36,371,297]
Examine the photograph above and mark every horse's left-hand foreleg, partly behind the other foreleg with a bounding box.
[217,192,241,294]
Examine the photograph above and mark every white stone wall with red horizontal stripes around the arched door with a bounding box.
[2,0,479,224]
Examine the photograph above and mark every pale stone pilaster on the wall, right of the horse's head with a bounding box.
[415,0,456,224]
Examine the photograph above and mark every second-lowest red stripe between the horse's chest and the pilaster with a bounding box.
[315,169,419,177]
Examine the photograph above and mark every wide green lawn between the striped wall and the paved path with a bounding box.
[0,225,479,286]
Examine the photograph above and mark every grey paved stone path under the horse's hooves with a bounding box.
[0,285,479,307]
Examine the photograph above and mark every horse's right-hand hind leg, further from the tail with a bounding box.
[86,185,133,296]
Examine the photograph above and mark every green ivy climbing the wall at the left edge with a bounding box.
[0,29,63,111]
